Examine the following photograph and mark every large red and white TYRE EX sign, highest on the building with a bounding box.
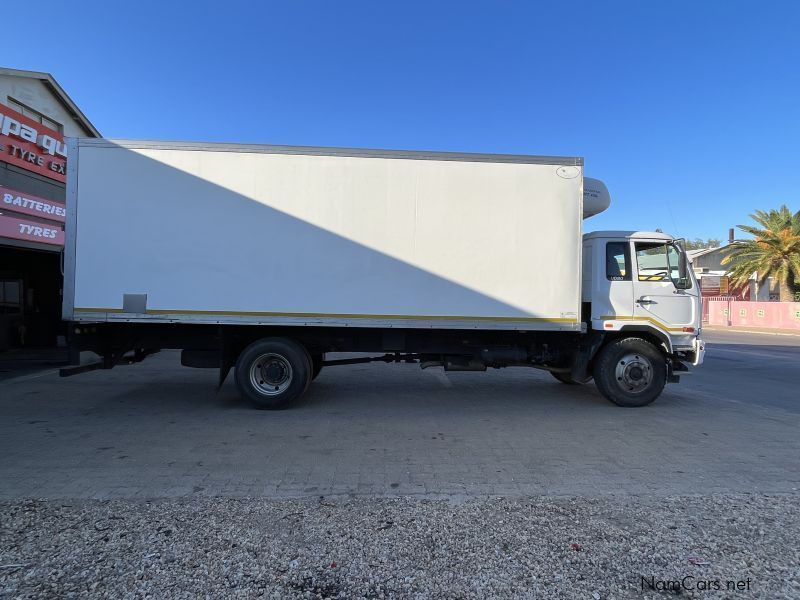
[0,104,67,182]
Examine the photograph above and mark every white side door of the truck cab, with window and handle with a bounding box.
[633,240,700,332]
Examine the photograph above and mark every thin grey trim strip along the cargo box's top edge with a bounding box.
[78,138,583,166]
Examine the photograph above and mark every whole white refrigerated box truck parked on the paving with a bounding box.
[62,139,704,408]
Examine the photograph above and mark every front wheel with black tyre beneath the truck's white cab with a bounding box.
[594,338,667,407]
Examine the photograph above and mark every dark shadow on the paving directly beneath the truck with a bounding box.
[78,365,616,418]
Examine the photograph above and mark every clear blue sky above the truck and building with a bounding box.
[0,0,800,239]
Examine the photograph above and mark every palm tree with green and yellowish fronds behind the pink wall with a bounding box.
[722,205,800,302]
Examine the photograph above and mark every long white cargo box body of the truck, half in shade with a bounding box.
[64,139,583,331]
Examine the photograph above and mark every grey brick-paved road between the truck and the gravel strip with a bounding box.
[0,332,800,499]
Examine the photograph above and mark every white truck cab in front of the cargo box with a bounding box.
[582,231,705,398]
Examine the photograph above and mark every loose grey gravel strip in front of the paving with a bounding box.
[0,495,800,600]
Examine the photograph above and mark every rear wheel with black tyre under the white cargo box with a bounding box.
[236,338,311,410]
